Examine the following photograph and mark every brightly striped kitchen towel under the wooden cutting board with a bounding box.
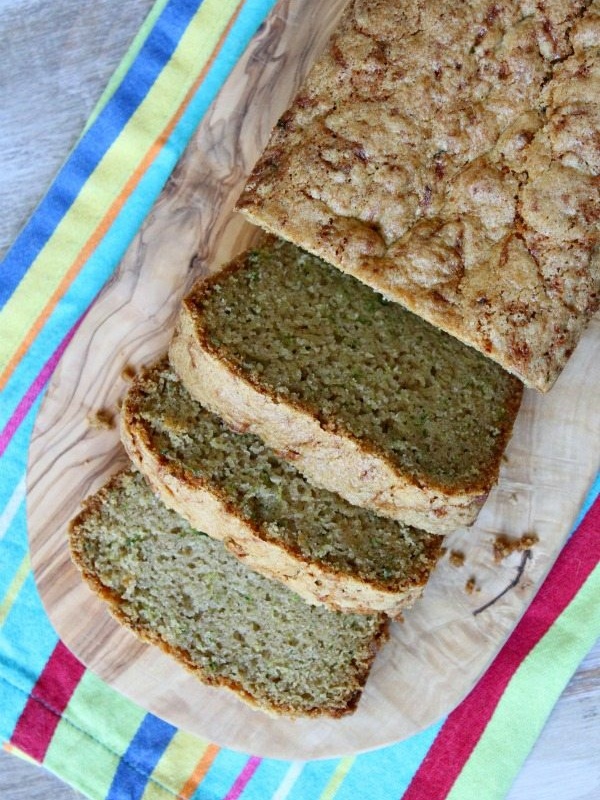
[0,0,600,800]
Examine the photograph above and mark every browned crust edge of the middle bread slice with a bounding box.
[121,364,442,617]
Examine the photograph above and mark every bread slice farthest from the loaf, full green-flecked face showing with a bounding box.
[70,470,388,717]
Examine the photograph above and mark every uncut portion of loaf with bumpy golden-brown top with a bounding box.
[238,0,600,391]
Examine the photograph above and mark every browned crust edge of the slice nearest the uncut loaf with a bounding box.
[169,240,522,535]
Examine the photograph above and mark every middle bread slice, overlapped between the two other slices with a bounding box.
[122,359,441,616]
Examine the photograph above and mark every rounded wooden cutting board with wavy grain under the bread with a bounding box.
[28,0,600,759]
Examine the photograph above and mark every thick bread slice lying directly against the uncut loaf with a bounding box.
[170,238,522,534]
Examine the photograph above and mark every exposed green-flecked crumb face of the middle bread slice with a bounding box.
[126,360,442,592]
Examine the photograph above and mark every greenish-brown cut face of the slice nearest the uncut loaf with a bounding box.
[195,239,522,496]
